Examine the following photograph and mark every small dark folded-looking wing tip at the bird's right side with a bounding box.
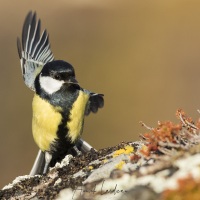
[84,90,104,115]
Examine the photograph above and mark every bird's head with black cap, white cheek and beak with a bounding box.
[39,60,80,94]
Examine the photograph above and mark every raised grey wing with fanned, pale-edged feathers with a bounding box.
[17,12,54,91]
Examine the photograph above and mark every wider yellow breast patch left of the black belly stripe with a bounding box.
[32,94,62,151]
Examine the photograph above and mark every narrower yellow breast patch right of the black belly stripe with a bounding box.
[67,91,89,142]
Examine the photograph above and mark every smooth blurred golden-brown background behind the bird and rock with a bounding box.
[0,0,200,188]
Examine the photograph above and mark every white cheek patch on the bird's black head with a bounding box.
[39,75,64,94]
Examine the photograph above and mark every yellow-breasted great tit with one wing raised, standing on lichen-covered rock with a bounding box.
[17,11,104,175]
